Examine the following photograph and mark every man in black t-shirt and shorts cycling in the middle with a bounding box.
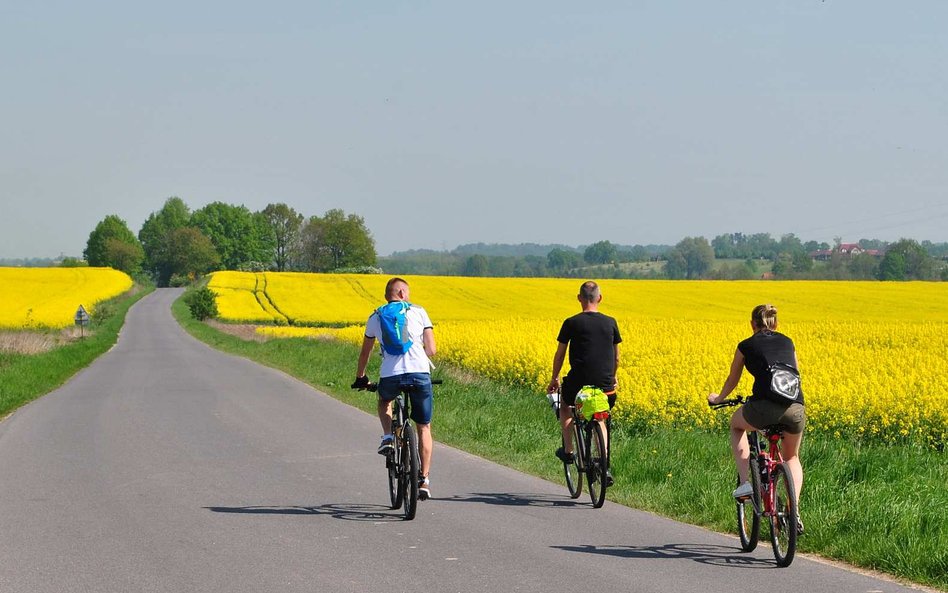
[547,280,622,470]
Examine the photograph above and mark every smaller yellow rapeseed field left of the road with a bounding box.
[0,268,132,329]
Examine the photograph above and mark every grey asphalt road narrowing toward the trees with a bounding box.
[0,289,924,593]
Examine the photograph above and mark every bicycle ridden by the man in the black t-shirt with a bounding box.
[548,392,612,509]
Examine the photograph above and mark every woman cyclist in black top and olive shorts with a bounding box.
[708,305,806,532]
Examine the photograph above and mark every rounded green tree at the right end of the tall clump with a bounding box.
[302,209,377,272]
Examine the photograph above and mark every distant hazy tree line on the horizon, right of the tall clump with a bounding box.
[379,233,948,280]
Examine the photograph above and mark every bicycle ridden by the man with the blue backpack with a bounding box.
[356,379,441,521]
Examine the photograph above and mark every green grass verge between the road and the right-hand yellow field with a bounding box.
[173,292,948,590]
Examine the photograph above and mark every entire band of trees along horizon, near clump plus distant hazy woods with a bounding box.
[79,197,948,286]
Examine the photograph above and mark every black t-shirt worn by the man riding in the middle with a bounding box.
[556,311,622,391]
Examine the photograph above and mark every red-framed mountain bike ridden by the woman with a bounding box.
[710,396,800,567]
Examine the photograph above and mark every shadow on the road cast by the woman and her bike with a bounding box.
[552,544,777,568]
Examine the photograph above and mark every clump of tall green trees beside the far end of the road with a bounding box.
[81,197,377,286]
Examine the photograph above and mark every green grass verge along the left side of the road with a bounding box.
[0,287,152,416]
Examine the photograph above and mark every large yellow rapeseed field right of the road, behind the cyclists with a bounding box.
[212,273,948,444]
